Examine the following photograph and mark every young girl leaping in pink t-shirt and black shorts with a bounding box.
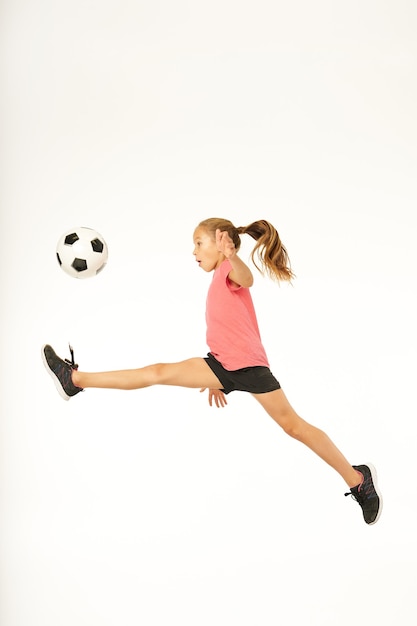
[42,218,382,524]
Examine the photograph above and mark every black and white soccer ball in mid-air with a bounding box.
[56,226,108,278]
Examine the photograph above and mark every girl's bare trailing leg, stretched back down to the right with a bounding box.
[252,389,362,487]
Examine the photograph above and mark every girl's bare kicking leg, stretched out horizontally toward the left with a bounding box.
[72,357,223,389]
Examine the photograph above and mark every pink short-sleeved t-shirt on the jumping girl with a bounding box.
[206,259,269,370]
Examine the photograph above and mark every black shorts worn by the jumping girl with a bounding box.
[204,352,281,393]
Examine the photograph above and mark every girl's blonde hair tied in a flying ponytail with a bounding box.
[198,217,295,282]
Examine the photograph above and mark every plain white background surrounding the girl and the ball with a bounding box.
[0,0,417,626]
